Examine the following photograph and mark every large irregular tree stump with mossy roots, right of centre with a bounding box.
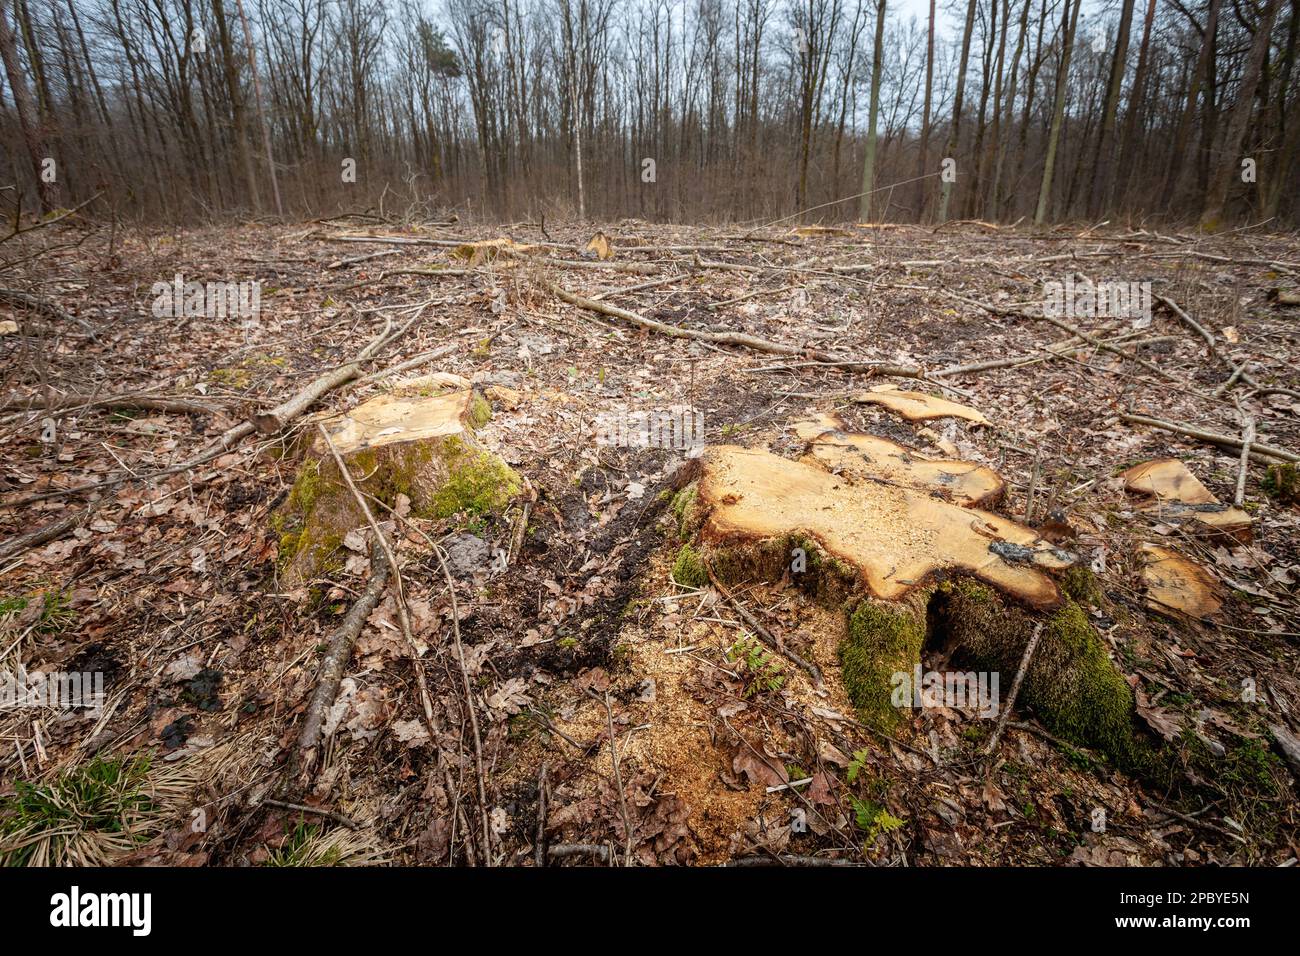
[673,426,1140,767]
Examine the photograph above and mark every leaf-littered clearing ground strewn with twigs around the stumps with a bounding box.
[0,217,1300,865]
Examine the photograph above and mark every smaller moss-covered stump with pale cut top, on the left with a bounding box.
[274,388,521,584]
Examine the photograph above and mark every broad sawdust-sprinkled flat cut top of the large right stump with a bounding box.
[696,445,1074,607]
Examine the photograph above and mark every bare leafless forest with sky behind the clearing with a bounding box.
[0,0,1300,228]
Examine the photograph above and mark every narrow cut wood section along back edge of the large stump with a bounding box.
[796,416,1006,507]
